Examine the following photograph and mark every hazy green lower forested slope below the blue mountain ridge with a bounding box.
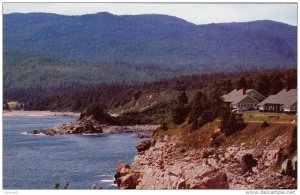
[3,51,183,89]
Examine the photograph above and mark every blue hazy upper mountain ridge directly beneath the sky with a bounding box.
[3,12,297,68]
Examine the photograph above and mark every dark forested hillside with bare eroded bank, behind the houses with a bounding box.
[3,69,297,123]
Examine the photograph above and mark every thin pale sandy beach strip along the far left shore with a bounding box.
[2,110,80,117]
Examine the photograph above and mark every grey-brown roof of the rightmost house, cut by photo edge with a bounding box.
[259,89,297,107]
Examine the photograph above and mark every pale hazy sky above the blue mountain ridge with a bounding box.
[3,3,297,26]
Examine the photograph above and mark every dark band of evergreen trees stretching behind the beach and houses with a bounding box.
[3,69,297,113]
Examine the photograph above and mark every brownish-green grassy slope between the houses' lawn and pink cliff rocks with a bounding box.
[154,121,296,154]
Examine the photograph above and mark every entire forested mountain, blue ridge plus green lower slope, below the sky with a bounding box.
[3,13,297,90]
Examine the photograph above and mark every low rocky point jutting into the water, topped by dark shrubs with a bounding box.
[28,117,158,137]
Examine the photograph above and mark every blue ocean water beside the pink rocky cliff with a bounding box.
[3,116,140,189]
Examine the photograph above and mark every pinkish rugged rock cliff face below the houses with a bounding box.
[118,122,297,189]
